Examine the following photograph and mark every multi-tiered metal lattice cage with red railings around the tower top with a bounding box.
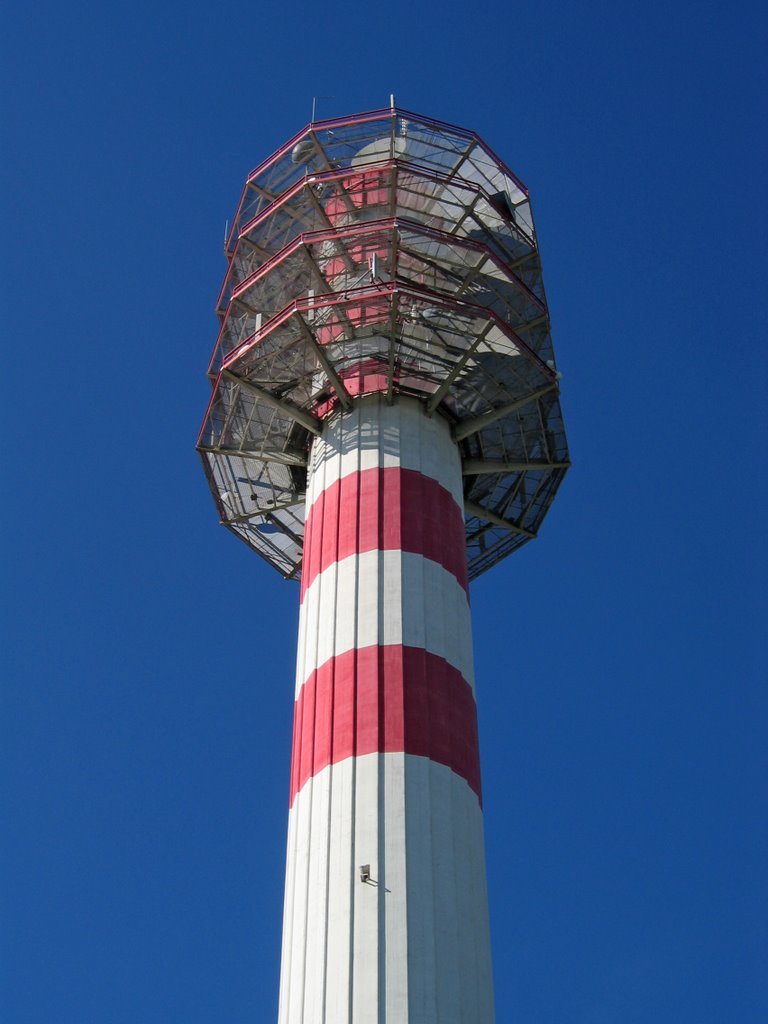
[198,108,569,579]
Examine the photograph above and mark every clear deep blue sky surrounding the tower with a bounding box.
[0,0,768,1024]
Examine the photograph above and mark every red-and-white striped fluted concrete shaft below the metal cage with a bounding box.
[279,395,494,1024]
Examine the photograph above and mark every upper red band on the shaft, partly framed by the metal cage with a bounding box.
[301,466,469,600]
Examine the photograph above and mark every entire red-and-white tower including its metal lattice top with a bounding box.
[198,108,568,1024]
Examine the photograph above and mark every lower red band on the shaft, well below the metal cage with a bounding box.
[291,644,481,806]
